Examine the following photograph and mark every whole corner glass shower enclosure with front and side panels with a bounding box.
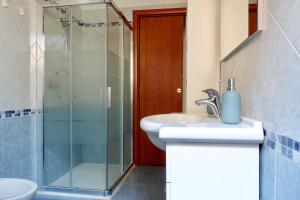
[43,1,132,192]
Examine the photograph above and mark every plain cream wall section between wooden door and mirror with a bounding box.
[185,0,220,112]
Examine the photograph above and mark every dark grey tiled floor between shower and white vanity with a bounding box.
[113,166,166,200]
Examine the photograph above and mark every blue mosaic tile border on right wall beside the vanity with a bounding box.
[264,129,300,164]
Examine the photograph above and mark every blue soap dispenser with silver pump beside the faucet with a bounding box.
[221,78,241,124]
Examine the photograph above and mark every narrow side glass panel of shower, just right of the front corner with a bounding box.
[107,5,123,187]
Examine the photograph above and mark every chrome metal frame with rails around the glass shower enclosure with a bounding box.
[41,0,134,196]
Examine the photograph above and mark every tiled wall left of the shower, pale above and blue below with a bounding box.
[0,0,42,183]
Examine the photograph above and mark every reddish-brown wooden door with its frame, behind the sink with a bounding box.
[134,9,186,165]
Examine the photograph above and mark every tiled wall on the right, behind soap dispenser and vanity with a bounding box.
[221,0,300,200]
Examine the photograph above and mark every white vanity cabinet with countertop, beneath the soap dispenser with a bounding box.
[159,119,263,200]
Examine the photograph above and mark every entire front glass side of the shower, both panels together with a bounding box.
[44,3,107,191]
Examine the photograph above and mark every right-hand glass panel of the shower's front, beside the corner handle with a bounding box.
[71,3,107,190]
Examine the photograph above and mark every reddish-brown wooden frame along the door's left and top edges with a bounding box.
[133,8,187,165]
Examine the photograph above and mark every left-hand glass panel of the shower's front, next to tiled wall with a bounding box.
[43,7,71,187]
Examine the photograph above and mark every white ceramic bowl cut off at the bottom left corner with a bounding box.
[0,178,37,200]
